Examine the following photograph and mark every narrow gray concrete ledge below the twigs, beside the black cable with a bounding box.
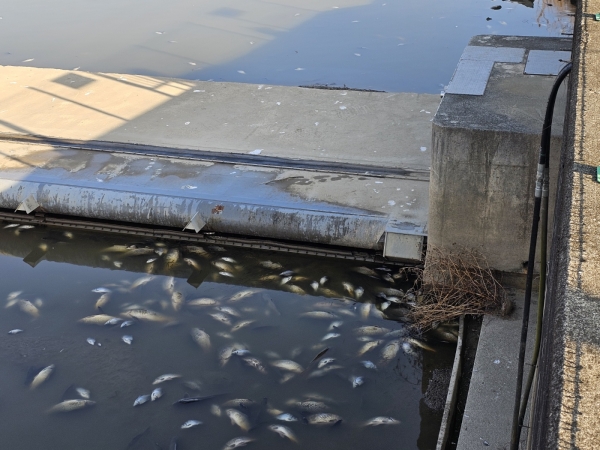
[456,291,537,450]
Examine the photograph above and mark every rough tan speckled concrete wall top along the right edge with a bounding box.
[533,0,600,449]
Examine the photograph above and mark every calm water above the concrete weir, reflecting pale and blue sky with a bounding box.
[0,0,574,93]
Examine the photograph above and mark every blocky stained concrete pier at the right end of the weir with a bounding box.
[428,36,571,273]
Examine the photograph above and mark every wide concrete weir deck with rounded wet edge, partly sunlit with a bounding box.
[0,67,439,260]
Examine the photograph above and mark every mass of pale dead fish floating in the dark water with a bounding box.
[4,224,458,450]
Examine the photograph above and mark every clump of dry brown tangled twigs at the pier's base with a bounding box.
[411,247,509,331]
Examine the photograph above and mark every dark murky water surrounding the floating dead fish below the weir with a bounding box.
[0,223,455,450]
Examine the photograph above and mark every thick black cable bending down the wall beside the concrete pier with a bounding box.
[510,63,573,450]
